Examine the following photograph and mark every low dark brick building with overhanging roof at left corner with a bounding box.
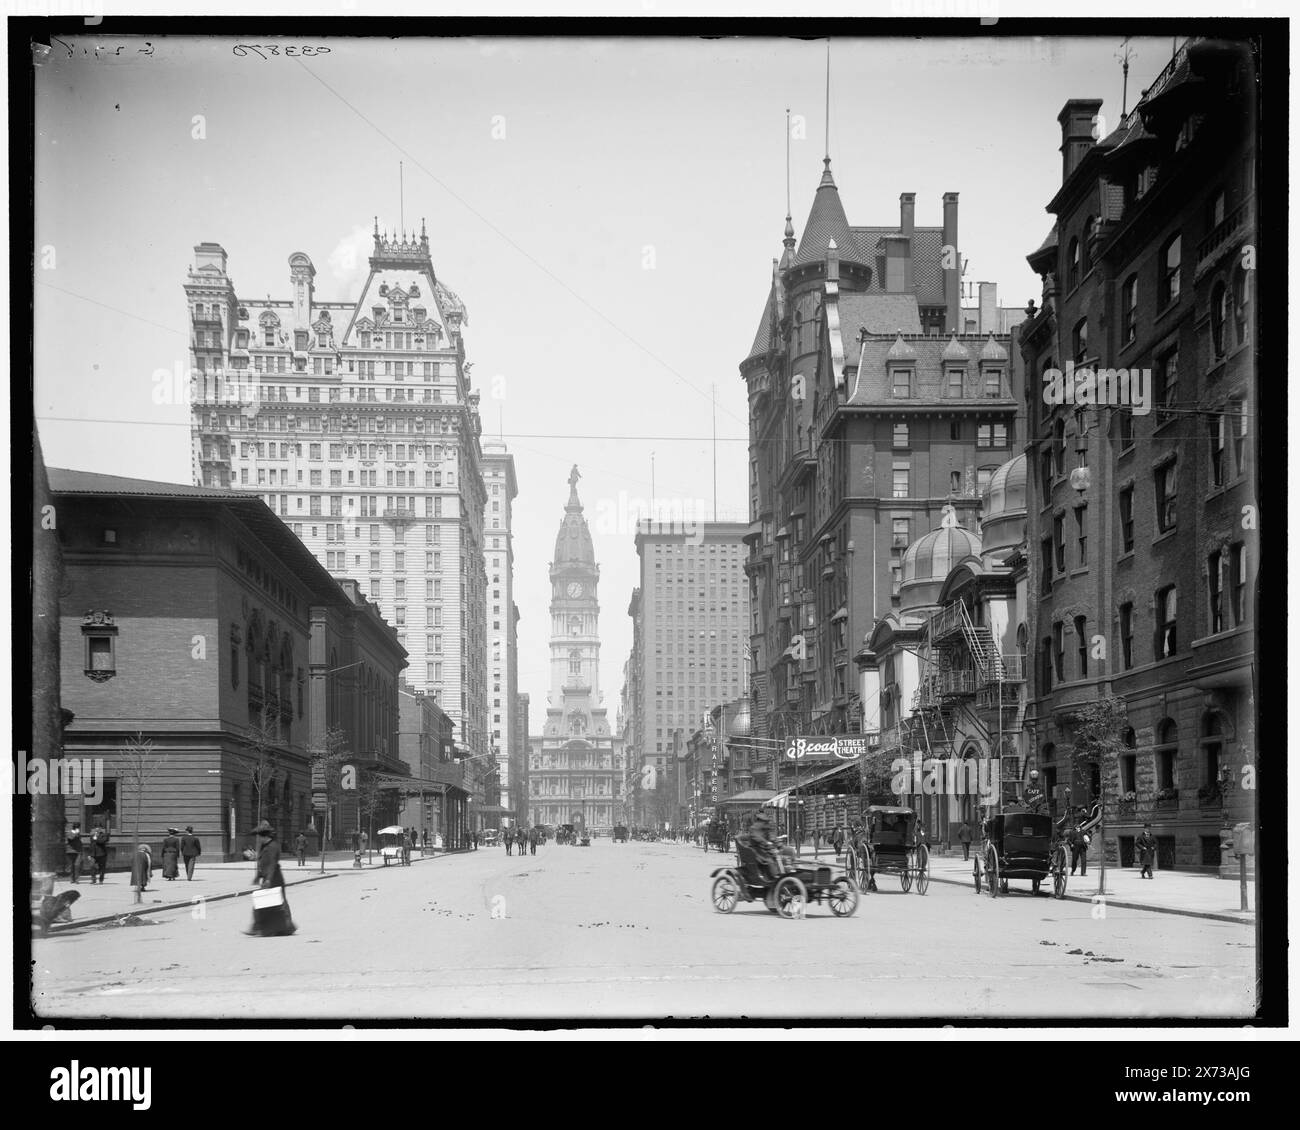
[49,468,410,858]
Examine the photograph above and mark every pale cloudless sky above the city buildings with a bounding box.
[35,36,1190,731]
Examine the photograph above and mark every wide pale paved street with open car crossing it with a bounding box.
[33,839,1255,1021]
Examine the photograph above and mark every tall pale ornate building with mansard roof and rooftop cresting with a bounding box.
[185,222,488,821]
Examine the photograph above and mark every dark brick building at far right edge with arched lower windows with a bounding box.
[1021,38,1260,869]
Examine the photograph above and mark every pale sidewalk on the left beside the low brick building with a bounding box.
[34,852,465,932]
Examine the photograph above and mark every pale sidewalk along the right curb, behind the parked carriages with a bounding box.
[780,844,1255,925]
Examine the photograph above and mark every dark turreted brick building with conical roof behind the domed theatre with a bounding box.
[741,157,1023,744]
